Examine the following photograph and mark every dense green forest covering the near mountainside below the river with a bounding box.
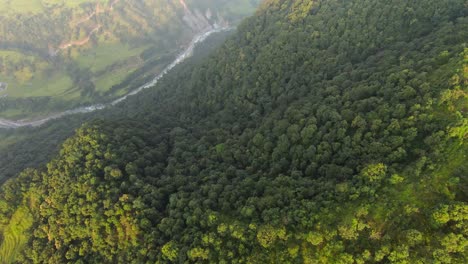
[0,0,468,263]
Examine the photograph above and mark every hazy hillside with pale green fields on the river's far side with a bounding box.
[0,0,258,119]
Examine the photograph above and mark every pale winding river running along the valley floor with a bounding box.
[0,25,230,128]
